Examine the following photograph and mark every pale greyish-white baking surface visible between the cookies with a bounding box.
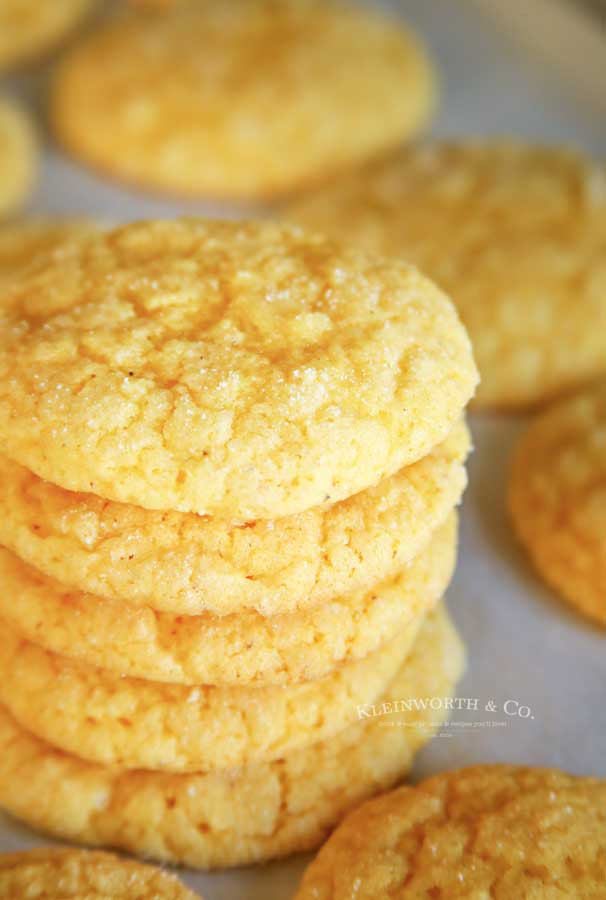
[0,0,606,900]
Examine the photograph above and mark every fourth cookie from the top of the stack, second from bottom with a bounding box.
[0,616,423,772]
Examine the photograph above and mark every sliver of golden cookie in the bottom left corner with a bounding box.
[0,847,198,900]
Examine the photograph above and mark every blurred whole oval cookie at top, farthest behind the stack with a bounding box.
[51,0,435,200]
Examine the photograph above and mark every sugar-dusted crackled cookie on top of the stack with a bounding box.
[0,219,476,522]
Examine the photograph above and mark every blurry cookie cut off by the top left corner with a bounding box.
[0,0,94,71]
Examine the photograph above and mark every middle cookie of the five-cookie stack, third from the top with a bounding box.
[0,516,457,685]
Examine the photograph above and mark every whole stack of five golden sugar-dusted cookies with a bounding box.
[0,220,477,867]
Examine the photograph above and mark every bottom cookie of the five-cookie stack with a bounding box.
[0,611,463,868]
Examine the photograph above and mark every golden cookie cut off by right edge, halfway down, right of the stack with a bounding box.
[509,383,606,625]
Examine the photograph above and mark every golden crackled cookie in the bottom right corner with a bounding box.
[296,765,606,900]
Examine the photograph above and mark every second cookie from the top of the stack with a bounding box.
[0,425,469,616]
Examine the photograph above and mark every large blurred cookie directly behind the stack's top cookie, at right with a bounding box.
[289,141,606,408]
